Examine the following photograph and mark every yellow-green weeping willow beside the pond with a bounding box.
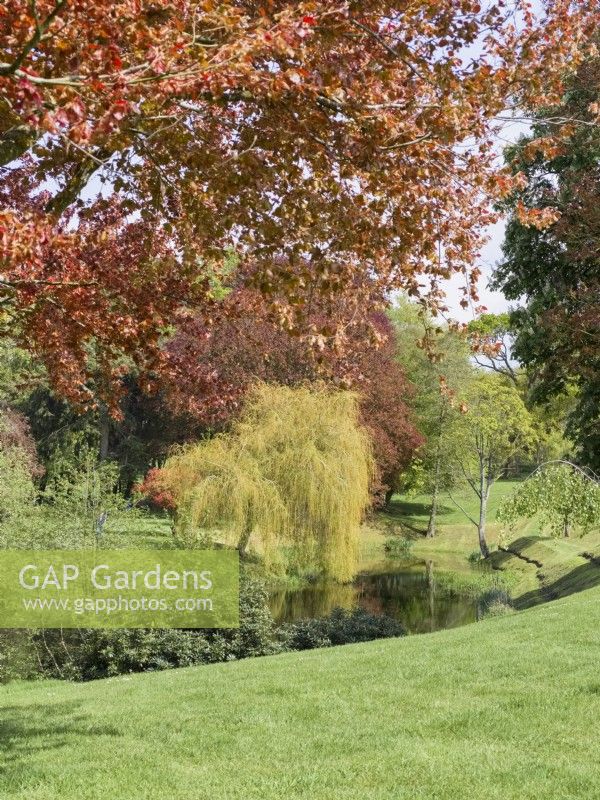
[162,384,373,581]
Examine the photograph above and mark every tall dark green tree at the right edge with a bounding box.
[496,48,600,469]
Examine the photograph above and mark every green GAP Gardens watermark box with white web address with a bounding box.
[0,550,239,628]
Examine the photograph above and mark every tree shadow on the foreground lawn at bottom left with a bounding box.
[0,700,121,797]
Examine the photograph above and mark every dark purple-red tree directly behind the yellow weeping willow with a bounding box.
[162,290,423,502]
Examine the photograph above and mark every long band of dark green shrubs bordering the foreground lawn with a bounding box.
[0,576,404,682]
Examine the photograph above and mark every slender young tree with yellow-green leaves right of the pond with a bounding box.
[451,374,533,558]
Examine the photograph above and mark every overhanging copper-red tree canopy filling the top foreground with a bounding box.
[0,0,594,405]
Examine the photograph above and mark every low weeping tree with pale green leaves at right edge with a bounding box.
[498,461,600,536]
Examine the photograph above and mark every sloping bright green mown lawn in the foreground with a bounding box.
[0,589,600,800]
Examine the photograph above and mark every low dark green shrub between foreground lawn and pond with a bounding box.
[281,608,405,650]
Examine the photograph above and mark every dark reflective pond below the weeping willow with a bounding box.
[270,561,477,633]
